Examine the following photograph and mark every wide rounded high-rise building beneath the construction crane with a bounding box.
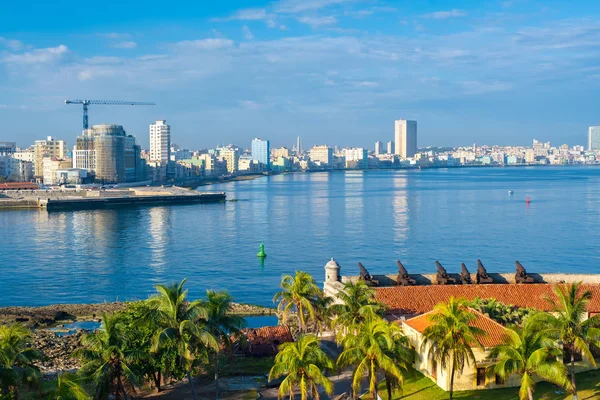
[73,124,145,183]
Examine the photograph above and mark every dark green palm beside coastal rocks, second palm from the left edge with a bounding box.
[75,313,142,400]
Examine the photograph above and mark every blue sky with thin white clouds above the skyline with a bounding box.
[0,0,600,149]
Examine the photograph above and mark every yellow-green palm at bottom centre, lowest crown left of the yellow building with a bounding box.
[269,335,334,400]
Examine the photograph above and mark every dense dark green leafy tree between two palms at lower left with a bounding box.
[116,301,186,392]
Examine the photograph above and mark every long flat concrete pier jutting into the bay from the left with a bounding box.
[0,186,226,212]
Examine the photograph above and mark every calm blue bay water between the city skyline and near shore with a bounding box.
[0,167,600,306]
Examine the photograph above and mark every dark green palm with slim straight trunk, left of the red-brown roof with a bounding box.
[204,290,246,398]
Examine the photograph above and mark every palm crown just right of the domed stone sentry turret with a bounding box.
[331,281,383,329]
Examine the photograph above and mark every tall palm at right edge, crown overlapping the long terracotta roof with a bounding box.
[538,283,600,400]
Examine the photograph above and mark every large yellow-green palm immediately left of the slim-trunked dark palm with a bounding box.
[147,279,218,400]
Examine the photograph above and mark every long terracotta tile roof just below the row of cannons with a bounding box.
[376,284,600,314]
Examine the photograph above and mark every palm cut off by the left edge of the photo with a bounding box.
[0,323,43,397]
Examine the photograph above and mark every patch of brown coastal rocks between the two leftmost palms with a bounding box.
[31,329,86,375]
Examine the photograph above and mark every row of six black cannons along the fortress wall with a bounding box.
[358,260,534,286]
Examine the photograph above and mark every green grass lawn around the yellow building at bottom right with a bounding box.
[365,371,600,400]
